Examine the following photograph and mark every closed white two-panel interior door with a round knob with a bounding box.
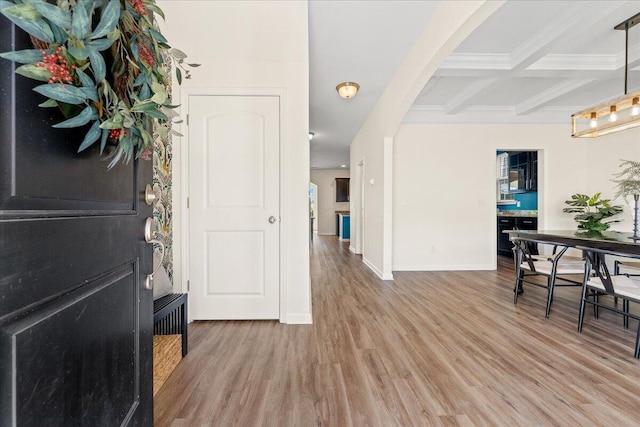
[188,95,280,320]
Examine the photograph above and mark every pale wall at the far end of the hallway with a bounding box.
[311,169,350,235]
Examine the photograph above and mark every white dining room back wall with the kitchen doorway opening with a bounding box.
[393,123,640,270]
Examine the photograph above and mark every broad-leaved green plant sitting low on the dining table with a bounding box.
[562,193,622,232]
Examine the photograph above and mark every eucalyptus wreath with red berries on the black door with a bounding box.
[0,0,199,168]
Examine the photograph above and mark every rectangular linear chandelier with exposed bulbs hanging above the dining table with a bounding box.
[571,13,640,138]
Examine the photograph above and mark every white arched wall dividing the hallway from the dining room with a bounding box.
[350,1,504,280]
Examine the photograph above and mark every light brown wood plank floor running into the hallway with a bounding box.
[155,236,640,427]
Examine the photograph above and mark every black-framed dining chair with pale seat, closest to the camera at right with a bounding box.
[577,247,640,359]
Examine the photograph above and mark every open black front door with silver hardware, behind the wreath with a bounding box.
[0,17,153,426]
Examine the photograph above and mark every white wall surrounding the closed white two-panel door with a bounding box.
[157,0,311,323]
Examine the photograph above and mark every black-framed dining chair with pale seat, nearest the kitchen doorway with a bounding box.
[511,236,584,318]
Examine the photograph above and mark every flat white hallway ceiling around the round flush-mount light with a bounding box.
[309,0,438,169]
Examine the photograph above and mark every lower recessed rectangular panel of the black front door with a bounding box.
[0,264,140,426]
